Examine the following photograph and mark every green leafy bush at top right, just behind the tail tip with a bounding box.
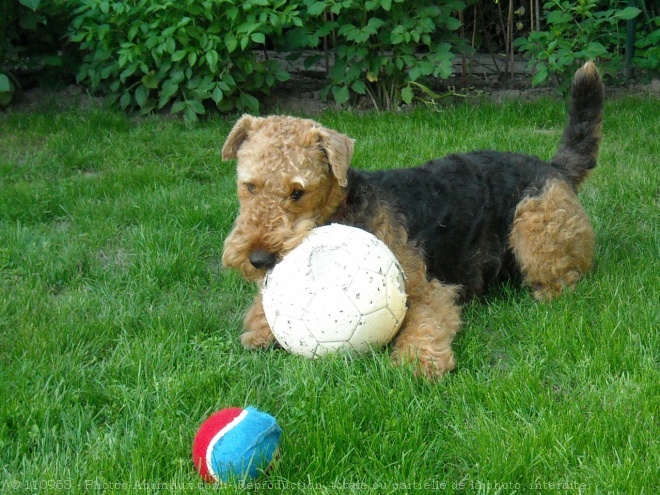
[514,0,641,90]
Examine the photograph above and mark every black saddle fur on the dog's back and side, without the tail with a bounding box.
[348,151,561,299]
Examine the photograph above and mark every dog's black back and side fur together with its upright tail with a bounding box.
[345,65,603,300]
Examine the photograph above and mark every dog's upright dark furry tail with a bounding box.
[551,62,604,187]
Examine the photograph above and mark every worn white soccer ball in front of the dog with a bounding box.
[262,224,406,358]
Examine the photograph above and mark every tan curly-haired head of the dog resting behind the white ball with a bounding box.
[222,115,353,280]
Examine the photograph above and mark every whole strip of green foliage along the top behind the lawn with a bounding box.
[0,0,660,117]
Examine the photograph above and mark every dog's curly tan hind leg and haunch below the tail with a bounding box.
[509,180,595,300]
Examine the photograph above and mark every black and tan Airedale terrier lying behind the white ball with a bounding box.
[222,62,603,377]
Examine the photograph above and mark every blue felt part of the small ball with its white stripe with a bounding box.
[207,407,282,482]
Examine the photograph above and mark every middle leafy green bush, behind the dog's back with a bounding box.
[287,0,465,108]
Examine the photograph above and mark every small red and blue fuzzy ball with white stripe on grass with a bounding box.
[193,407,282,483]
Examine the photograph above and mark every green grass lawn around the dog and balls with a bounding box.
[0,98,660,494]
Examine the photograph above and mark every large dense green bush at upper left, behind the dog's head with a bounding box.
[71,0,302,121]
